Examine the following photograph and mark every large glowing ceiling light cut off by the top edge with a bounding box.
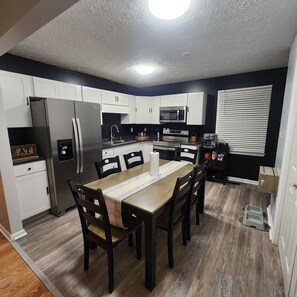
[148,0,191,20]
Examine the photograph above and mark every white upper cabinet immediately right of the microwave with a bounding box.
[187,92,207,125]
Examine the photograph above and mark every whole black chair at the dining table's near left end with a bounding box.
[67,179,142,293]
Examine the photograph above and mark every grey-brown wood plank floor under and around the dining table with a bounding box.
[18,182,284,297]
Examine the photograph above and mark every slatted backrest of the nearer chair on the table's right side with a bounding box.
[169,169,195,224]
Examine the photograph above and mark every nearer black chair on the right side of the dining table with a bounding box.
[157,170,194,268]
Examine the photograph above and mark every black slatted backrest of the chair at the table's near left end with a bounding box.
[67,179,112,246]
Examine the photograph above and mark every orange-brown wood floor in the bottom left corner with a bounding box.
[0,232,52,297]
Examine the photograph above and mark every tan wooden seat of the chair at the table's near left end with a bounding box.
[88,216,141,244]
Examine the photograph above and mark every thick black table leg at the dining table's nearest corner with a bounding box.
[144,217,156,291]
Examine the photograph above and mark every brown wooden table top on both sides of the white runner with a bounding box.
[85,159,195,213]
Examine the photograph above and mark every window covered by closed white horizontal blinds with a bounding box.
[216,85,272,156]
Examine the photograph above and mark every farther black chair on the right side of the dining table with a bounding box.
[187,161,207,240]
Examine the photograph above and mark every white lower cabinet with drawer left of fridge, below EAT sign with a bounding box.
[14,161,51,220]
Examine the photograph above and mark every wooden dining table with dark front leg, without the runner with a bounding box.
[85,160,195,291]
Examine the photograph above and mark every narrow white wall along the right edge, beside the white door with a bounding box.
[272,35,297,244]
